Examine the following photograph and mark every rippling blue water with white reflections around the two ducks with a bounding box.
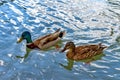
[0,0,120,80]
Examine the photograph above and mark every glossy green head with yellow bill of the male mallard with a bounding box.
[17,31,32,43]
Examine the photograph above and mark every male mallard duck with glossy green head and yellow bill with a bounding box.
[17,29,65,50]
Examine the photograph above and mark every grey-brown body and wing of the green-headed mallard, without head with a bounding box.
[33,29,65,48]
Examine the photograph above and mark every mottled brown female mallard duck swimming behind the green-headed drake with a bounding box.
[61,42,106,60]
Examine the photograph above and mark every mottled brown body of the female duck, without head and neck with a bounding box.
[74,44,105,60]
